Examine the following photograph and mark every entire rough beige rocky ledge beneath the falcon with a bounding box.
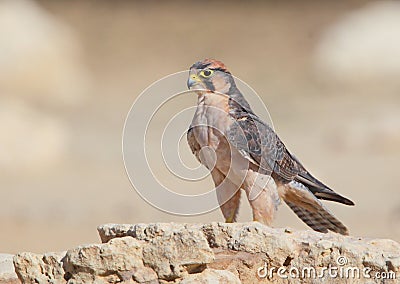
[0,223,400,284]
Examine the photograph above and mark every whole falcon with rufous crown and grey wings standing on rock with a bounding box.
[187,59,354,235]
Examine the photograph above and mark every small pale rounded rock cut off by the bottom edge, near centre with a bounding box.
[180,269,241,284]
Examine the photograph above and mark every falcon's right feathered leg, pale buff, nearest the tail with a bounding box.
[243,170,280,226]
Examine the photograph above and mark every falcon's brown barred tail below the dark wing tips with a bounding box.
[280,181,349,235]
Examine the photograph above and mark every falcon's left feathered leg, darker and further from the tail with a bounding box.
[211,168,241,223]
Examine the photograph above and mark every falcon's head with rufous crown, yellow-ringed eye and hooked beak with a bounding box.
[187,58,236,94]
